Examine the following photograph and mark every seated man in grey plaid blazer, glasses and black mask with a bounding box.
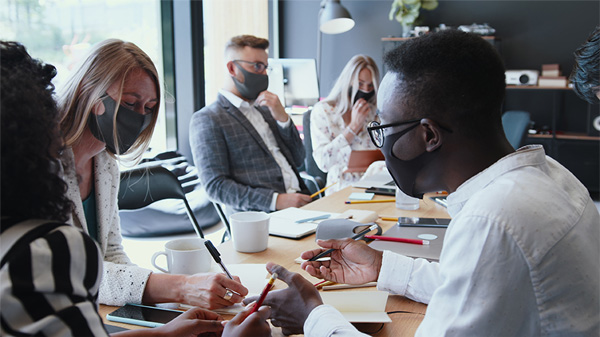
[190,35,311,213]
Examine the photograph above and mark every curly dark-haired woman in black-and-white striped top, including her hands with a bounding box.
[0,41,270,336]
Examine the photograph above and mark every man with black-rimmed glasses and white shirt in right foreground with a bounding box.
[244,31,600,336]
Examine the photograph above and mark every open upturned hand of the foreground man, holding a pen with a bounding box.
[301,224,383,284]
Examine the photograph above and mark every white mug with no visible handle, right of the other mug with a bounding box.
[229,212,270,253]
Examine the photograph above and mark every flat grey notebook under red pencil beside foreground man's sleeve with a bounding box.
[369,225,446,261]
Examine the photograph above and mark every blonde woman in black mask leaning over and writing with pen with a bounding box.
[59,39,248,309]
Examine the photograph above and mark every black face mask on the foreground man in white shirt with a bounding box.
[381,123,432,199]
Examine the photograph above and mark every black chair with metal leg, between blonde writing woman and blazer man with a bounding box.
[118,165,204,238]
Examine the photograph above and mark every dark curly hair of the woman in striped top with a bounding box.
[0,41,72,222]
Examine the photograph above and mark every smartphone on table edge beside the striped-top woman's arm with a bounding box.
[106,304,183,328]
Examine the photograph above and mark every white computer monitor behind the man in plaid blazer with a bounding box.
[267,58,319,107]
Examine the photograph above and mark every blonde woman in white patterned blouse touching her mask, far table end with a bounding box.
[310,55,379,194]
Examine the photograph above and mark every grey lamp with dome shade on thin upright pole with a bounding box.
[317,0,354,78]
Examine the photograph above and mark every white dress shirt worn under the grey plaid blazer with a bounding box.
[219,89,300,211]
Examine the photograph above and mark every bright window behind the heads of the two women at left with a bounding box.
[0,0,173,153]
